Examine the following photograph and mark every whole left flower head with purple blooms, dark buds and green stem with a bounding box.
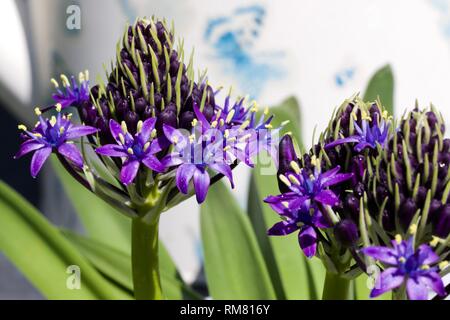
[17,18,279,299]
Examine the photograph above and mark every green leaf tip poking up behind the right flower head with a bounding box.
[364,65,394,115]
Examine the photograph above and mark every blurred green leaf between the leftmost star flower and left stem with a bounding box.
[52,159,131,254]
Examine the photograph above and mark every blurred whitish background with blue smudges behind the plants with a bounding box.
[0,0,450,299]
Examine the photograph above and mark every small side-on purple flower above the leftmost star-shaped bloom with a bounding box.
[52,71,90,108]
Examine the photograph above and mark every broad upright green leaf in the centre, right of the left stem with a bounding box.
[200,182,276,300]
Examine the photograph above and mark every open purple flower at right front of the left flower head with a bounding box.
[163,125,234,203]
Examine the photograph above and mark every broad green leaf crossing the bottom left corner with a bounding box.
[0,181,131,299]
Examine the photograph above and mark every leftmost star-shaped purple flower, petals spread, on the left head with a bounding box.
[14,105,97,178]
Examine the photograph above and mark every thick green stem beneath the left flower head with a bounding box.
[131,216,163,300]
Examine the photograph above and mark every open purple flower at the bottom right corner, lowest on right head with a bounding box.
[361,235,446,300]
